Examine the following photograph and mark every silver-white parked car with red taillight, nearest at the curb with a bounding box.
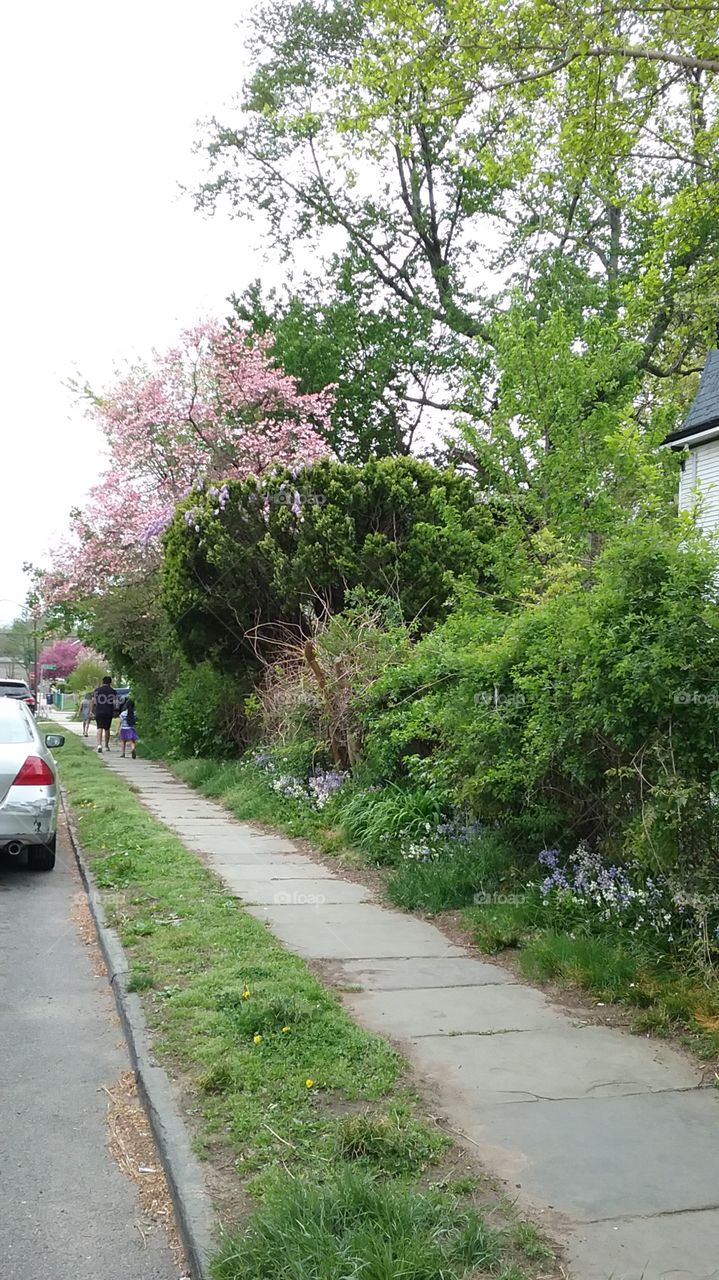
[0,698,65,872]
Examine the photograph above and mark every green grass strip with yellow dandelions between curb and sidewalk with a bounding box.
[60,735,555,1280]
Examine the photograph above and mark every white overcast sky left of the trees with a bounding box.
[0,0,268,621]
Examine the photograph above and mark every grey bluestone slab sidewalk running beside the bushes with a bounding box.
[58,717,719,1280]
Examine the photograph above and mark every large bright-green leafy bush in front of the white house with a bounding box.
[361,524,719,868]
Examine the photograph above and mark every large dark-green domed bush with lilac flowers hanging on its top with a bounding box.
[162,458,495,669]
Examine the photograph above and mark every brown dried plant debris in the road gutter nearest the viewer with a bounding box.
[105,1071,187,1275]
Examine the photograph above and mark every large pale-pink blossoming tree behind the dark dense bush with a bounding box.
[43,321,333,603]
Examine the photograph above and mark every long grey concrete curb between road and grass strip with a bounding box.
[60,787,216,1280]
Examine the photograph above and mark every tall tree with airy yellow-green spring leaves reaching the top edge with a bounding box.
[201,0,719,536]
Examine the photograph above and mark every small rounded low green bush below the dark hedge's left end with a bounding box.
[160,662,246,759]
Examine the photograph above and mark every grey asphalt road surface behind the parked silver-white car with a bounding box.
[0,819,179,1280]
